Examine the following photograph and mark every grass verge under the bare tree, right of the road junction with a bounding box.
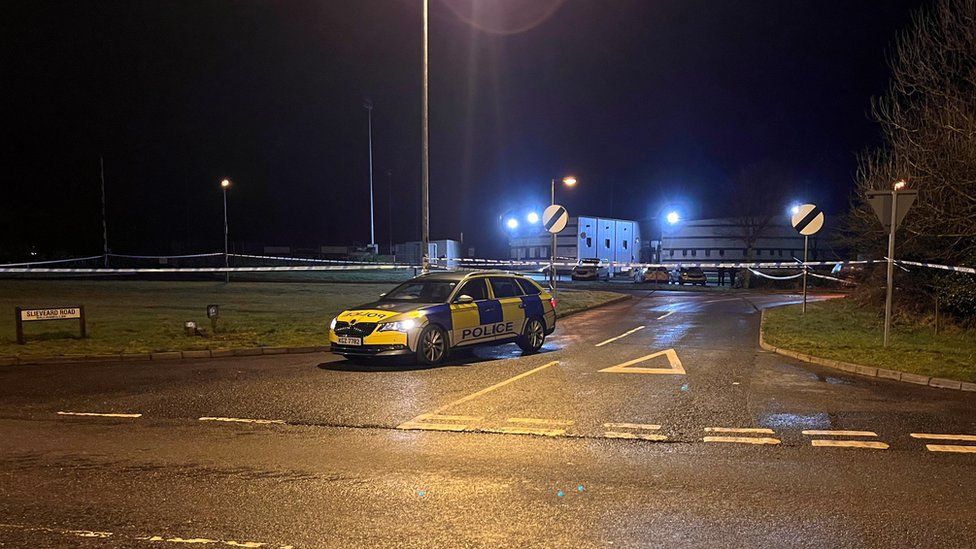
[765,299,976,381]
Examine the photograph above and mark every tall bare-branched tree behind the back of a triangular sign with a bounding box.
[847,0,976,263]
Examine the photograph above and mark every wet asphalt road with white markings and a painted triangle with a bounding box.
[0,291,976,547]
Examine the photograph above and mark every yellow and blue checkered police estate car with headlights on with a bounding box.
[329,272,556,364]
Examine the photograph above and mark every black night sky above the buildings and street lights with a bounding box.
[0,0,921,257]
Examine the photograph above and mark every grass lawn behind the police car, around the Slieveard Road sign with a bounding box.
[0,280,620,356]
